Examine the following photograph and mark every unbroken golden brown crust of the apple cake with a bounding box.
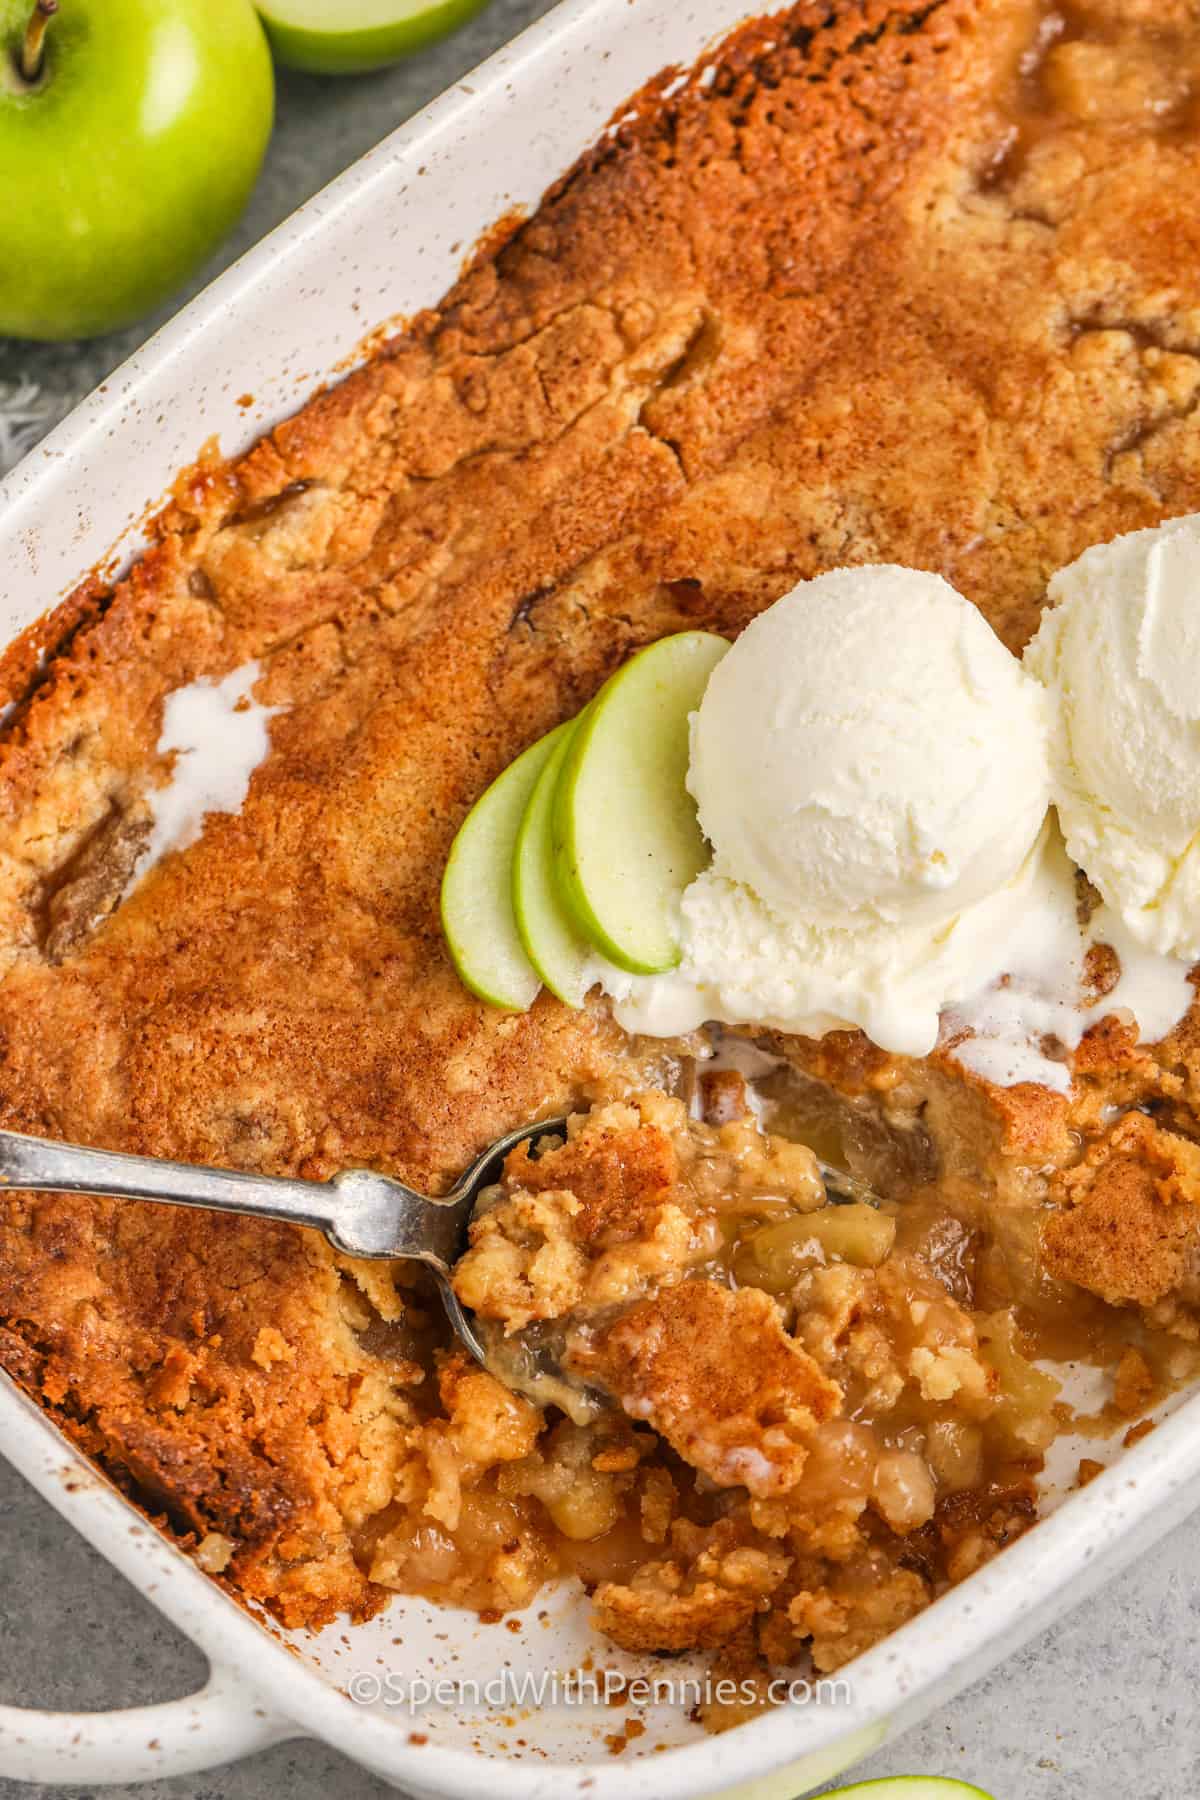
[0,0,1200,1622]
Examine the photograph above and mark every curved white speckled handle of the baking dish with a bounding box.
[0,1667,302,1787]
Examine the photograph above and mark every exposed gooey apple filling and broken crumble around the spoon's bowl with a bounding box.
[392,1033,1200,1672]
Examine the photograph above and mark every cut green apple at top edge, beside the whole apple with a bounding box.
[259,0,488,76]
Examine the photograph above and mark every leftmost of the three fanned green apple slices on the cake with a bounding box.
[441,722,572,1012]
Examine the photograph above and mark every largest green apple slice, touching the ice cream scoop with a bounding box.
[554,632,729,976]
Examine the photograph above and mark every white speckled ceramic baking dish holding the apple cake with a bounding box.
[0,0,1200,1800]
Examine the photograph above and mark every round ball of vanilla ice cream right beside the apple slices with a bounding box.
[687,565,1049,927]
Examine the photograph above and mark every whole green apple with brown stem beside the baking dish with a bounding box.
[0,0,275,338]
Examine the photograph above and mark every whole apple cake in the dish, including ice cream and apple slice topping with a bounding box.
[0,0,1200,1699]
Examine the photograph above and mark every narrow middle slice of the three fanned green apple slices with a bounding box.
[513,715,599,1006]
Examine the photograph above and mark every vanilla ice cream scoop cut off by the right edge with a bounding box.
[1025,513,1200,959]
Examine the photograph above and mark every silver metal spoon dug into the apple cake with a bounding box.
[0,1118,567,1368]
